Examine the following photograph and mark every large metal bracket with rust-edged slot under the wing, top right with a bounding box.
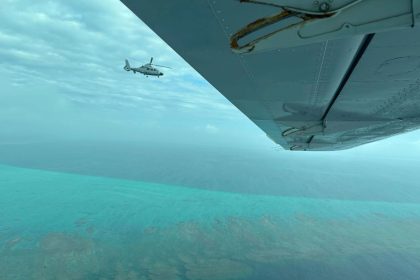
[230,0,420,54]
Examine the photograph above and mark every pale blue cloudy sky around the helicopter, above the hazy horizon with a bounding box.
[0,0,420,157]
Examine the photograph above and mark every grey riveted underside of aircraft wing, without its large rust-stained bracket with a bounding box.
[122,0,420,150]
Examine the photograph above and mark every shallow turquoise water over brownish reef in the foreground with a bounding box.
[0,165,420,279]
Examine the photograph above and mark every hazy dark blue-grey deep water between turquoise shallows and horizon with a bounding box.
[0,142,420,203]
